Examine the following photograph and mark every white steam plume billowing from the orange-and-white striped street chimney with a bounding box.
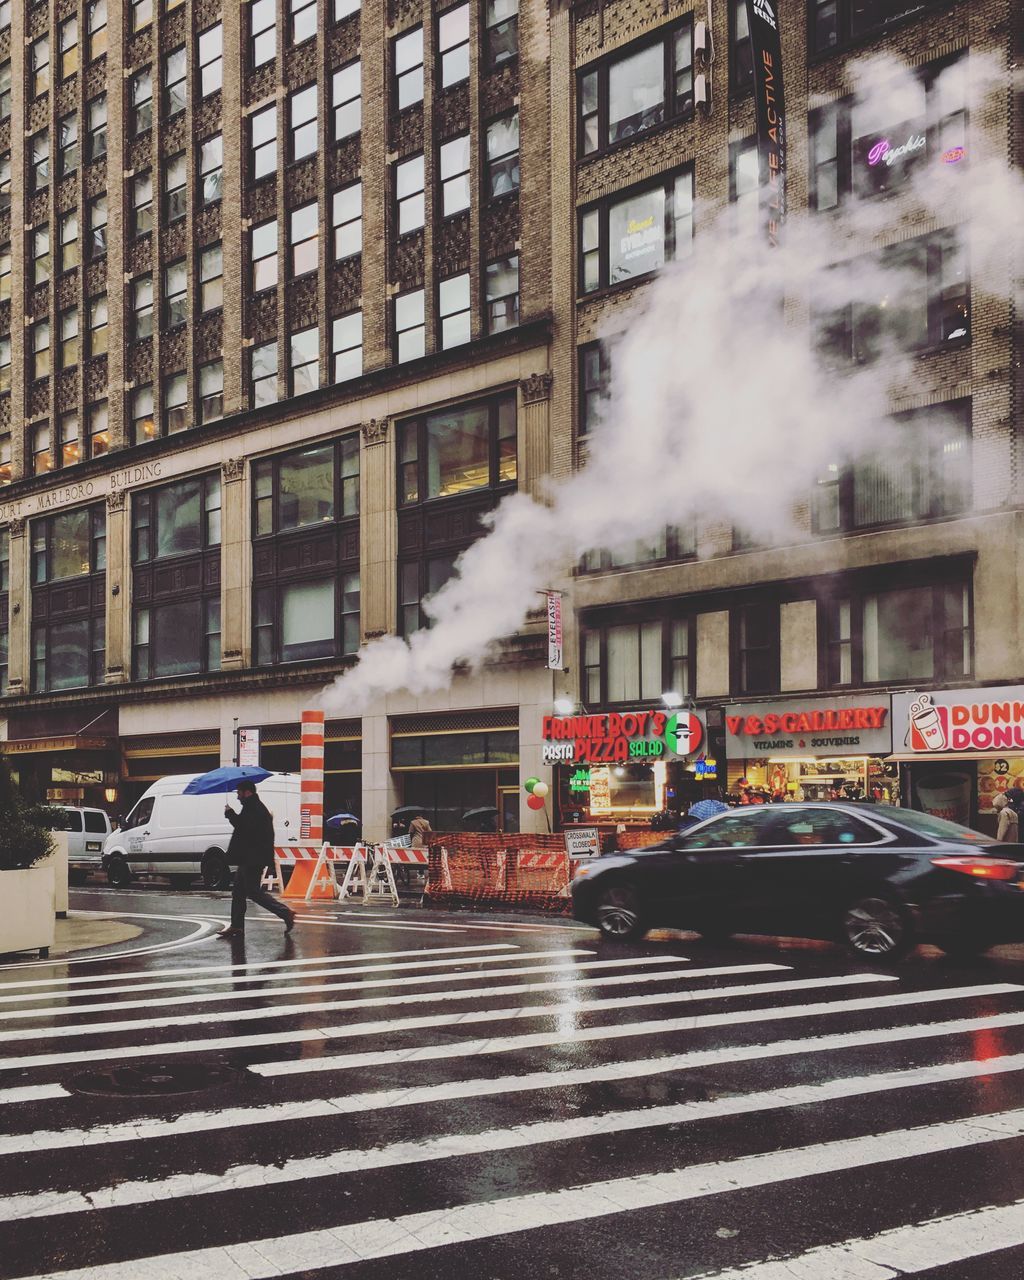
[324,55,1024,716]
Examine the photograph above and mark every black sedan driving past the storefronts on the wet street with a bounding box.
[572,803,1024,959]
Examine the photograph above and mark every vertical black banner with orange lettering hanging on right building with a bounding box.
[746,0,786,247]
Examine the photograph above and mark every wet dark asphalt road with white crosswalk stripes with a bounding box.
[0,887,1024,1280]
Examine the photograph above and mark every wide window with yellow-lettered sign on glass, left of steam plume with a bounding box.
[579,170,694,293]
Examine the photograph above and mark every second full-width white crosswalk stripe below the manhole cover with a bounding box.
[0,1053,1024,1222]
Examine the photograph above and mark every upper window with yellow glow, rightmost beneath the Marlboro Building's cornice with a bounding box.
[398,396,517,506]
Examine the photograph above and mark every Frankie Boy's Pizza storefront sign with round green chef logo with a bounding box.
[541,710,704,764]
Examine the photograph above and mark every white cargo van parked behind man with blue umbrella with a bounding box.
[102,773,301,888]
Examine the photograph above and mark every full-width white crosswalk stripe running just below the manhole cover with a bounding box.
[10,1014,1024,1157]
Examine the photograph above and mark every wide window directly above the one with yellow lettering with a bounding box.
[579,18,694,155]
